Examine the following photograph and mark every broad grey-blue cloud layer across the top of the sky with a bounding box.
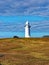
[0,0,49,16]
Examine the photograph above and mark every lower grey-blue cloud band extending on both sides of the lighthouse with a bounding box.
[0,21,49,32]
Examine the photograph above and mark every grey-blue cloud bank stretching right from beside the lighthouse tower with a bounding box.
[31,21,49,32]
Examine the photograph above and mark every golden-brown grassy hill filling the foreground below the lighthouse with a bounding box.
[0,38,49,65]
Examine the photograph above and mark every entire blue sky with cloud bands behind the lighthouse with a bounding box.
[0,0,49,38]
